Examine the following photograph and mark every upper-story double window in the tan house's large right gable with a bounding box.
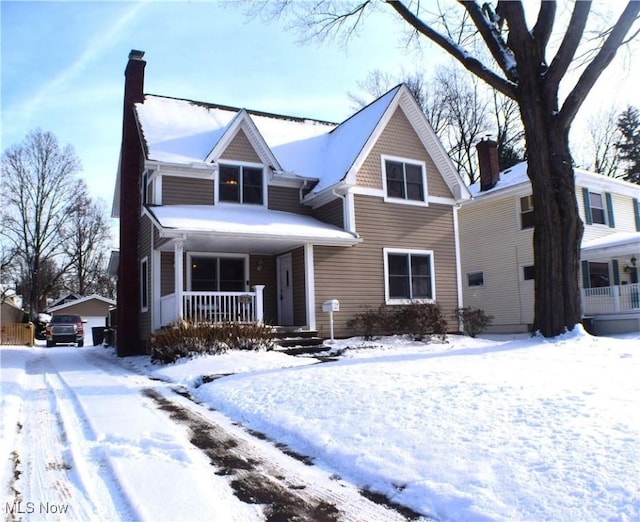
[383,157,427,205]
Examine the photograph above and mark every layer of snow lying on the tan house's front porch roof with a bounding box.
[149,203,360,246]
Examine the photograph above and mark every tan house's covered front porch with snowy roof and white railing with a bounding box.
[152,205,359,329]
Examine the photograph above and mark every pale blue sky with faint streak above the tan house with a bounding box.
[0,1,640,205]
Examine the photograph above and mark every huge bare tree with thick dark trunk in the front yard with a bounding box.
[260,0,640,337]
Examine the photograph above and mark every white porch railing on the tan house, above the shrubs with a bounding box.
[160,285,264,326]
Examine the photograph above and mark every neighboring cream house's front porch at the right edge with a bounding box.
[581,233,640,334]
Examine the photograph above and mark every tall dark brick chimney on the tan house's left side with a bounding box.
[116,50,146,357]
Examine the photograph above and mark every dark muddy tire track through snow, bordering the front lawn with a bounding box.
[143,388,427,522]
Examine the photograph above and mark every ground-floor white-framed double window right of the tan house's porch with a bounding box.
[384,248,435,304]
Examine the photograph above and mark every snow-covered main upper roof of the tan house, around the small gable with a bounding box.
[136,85,444,193]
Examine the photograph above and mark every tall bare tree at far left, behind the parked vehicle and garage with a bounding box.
[0,130,82,317]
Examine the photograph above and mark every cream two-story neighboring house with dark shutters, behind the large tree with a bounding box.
[459,141,640,334]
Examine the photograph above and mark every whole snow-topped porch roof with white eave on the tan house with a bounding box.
[149,203,360,253]
